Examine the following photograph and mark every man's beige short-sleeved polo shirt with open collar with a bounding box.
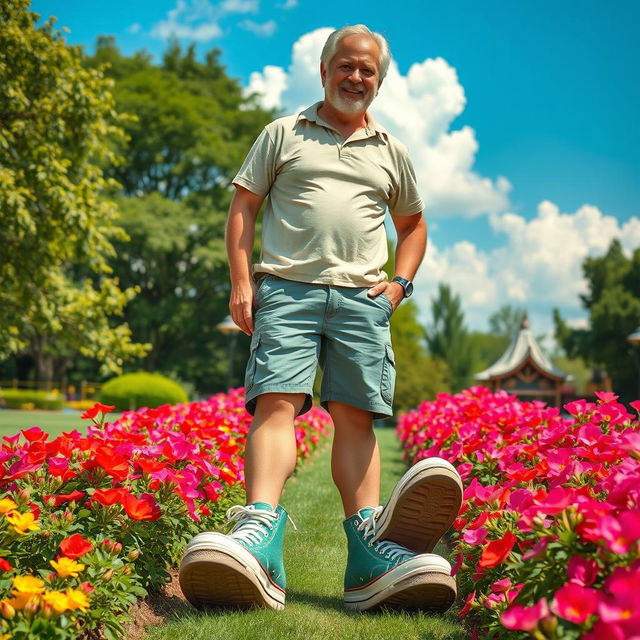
[233,102,424,287]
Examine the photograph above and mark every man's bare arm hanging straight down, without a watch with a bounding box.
[225,185,264,336]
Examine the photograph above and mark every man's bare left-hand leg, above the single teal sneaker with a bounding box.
[244,393,305,507]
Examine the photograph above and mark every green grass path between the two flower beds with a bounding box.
[145,429,467,640]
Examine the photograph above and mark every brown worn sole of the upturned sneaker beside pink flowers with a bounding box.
[375,458,463,553]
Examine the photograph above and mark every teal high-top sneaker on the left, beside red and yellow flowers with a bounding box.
[179,502,288,609]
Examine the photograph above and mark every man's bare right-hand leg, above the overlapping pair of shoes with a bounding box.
[329,402,380,518]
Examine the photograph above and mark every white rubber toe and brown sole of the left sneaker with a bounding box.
[178,534,285,610]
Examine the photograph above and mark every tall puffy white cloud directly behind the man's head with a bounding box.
[247,28,511,216]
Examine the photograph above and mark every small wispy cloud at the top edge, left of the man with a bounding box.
[151,0,259,42]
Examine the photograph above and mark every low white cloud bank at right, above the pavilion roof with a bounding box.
[415,201,640,333]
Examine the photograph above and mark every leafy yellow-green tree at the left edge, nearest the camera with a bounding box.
[0,0,145,381]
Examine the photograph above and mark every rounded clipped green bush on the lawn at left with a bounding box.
[100,371,189,411]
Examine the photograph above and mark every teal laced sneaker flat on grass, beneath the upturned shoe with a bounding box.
[344,507,456,611]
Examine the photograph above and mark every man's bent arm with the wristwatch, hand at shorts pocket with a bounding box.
[368,213,427,309]
